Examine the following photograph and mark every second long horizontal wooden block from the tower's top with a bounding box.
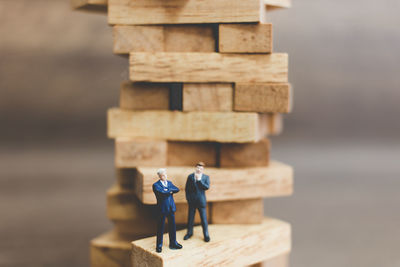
[129,52,288,83]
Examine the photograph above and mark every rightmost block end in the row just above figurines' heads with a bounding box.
[219,139,270,168]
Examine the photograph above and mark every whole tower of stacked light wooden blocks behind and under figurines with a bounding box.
[72,0,293,267]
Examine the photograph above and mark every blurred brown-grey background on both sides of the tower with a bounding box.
[0,0,400,267]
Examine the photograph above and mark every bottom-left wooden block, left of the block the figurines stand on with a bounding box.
[90,232,133,267]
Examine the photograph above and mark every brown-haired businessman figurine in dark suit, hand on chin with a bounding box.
[183,162,210,242]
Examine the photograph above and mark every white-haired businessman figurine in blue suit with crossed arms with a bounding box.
[153,169,182,252]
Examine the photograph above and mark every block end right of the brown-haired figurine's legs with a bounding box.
[211,198,264,224]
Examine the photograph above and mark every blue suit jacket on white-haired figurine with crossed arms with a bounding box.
[153,180,179,215]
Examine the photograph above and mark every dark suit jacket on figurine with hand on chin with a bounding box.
[185,173,210,208]
